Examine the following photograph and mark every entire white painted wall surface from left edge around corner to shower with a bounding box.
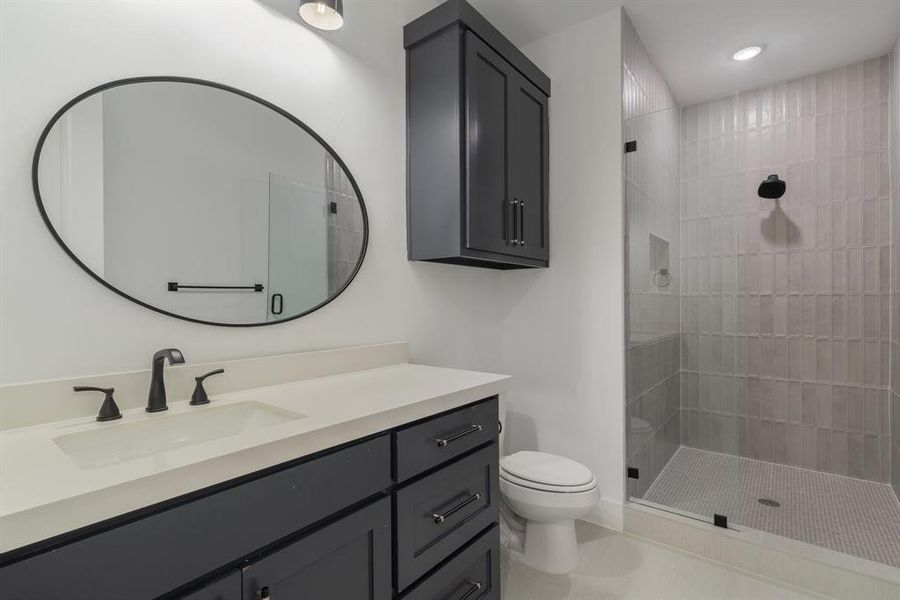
[0,0,624,502]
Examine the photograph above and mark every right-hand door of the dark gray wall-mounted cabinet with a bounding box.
[509,73,550,259]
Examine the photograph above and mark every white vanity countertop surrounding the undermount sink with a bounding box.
[0,364,509,554]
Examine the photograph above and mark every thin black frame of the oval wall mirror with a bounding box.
[31,75,369,327]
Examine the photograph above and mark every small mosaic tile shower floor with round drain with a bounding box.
[644,447,900,567]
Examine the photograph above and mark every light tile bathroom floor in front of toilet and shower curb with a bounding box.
[501,521,816,600]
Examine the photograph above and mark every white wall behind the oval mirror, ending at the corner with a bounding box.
[0,0,501,383]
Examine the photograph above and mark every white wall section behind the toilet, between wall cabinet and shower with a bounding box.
[502,10,625,502]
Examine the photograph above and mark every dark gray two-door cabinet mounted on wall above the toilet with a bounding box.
[404,0,550,269]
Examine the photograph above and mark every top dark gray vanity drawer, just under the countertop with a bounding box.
[394,396,498,481]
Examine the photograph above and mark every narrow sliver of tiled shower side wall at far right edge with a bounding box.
[890,40,900,499]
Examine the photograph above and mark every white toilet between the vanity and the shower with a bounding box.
[500,451,600,574]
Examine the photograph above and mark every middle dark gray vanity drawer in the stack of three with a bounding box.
[395,444,500,591]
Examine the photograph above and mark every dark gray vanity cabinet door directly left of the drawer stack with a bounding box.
[243,498,392,600]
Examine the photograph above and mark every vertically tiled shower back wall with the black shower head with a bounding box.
[681,56,891,482]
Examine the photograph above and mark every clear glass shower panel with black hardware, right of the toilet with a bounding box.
[624,108,740,522]
